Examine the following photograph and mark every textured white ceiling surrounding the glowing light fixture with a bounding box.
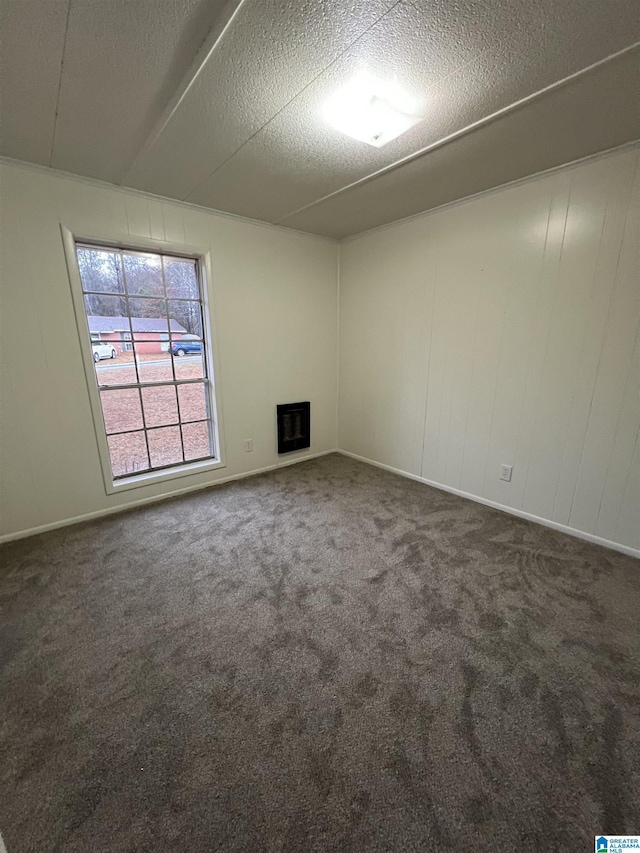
[0,0,640,238]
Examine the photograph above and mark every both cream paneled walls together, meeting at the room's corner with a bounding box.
[0,148,640,549]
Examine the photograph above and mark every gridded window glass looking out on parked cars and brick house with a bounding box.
[74,242,220,486]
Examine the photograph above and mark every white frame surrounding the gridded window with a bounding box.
[60,224,227,495]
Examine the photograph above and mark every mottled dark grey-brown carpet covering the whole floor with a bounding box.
[0,455,640,853]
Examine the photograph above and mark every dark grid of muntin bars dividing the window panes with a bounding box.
[76,242,216,482]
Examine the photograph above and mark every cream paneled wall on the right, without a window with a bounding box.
[338,148,640,548]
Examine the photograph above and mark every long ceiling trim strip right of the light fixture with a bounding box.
[276,42,640,226]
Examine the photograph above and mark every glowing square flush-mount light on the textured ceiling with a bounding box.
[324,72,423,148]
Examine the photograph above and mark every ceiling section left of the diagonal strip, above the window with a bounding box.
[0,0,234,183]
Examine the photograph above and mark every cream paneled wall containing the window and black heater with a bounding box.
[0,164,338,536]
